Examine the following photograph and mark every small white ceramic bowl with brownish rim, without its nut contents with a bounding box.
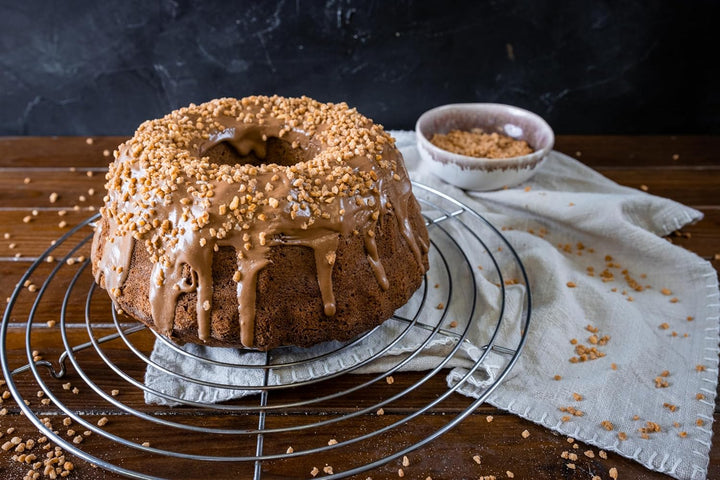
[415,103,555,190]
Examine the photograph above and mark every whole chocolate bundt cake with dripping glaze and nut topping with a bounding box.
[92,96,428,350]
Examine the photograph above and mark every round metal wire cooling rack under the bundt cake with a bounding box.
[0,184,531,479]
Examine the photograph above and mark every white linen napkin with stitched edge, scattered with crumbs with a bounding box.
[145,131,720,479]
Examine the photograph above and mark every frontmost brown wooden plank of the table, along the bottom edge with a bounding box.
[0,412,720,480]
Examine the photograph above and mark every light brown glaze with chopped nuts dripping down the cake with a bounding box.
[94,97,427,347]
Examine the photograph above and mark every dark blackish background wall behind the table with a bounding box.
[0,0,720,135]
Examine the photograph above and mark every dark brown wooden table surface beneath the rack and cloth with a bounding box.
[0,136,720,479]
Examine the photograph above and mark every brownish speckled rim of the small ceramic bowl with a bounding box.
[415,103,555,170]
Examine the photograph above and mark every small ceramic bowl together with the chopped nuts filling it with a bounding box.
[415,103,555,191]
